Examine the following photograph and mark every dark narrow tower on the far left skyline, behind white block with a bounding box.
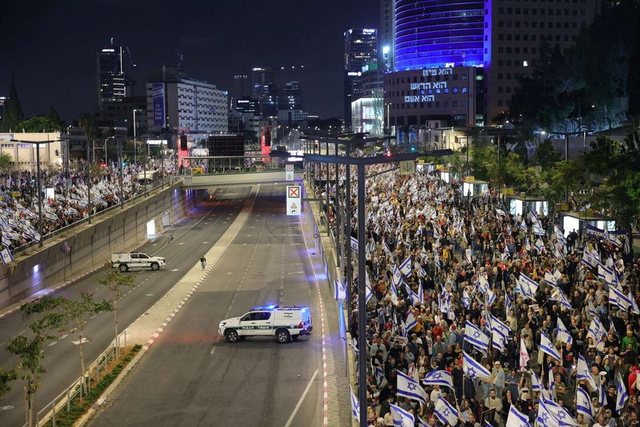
[96,41,126,110]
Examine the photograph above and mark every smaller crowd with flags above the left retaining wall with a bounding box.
[0,162,173,252]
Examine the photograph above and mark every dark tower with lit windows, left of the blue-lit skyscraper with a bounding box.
[344,28,378,129]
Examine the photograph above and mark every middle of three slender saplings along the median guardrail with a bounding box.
[59,292,111,394]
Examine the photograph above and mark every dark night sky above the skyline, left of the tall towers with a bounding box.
[0,0,379,122]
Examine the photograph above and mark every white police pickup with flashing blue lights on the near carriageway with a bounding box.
[218,305,313,344]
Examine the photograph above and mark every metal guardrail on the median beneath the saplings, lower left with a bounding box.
[28,331,127,427]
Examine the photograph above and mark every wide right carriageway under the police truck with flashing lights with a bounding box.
[90,185,335,427]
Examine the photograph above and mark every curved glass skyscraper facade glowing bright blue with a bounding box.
[394,0,492,71]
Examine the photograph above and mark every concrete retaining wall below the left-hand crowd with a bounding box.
[0,184,187,309]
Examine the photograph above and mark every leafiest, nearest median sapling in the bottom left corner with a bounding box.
[6,296,65,427]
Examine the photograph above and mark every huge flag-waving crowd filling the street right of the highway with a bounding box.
[349,168,640,427]
